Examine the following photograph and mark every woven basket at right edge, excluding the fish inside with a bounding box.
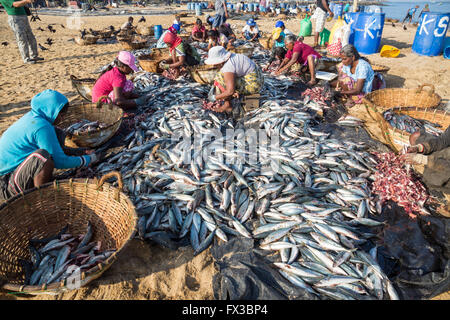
[366,105,450,152]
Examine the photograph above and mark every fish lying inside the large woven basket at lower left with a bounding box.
[20,222,115,286]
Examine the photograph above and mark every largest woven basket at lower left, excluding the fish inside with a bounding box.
[0,172,137,294]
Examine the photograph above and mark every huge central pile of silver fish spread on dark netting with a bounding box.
[88,43,398,299]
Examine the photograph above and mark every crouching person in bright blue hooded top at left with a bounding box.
[0,90,101,200]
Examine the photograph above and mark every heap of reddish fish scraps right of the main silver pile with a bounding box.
[372,153,430,218]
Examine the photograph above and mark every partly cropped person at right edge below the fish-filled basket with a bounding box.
[406,126,450,217]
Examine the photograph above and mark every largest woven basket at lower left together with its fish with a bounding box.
[0,172,137,294]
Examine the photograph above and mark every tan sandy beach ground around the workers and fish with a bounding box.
[0,6,450,300]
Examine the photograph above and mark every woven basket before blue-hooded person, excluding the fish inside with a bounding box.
[55,96,123,148]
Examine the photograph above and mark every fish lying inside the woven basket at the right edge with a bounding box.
[383,110,443,136]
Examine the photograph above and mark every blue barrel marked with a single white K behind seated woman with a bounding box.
[354,12,385,54]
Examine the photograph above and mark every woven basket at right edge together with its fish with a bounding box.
[380,107,450,152]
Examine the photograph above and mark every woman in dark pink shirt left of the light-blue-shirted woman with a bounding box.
[275,34,322,85]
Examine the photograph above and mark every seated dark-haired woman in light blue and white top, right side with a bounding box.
[331,44,375,106]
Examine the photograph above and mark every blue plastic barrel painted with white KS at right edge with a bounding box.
[412,12,450,56]
